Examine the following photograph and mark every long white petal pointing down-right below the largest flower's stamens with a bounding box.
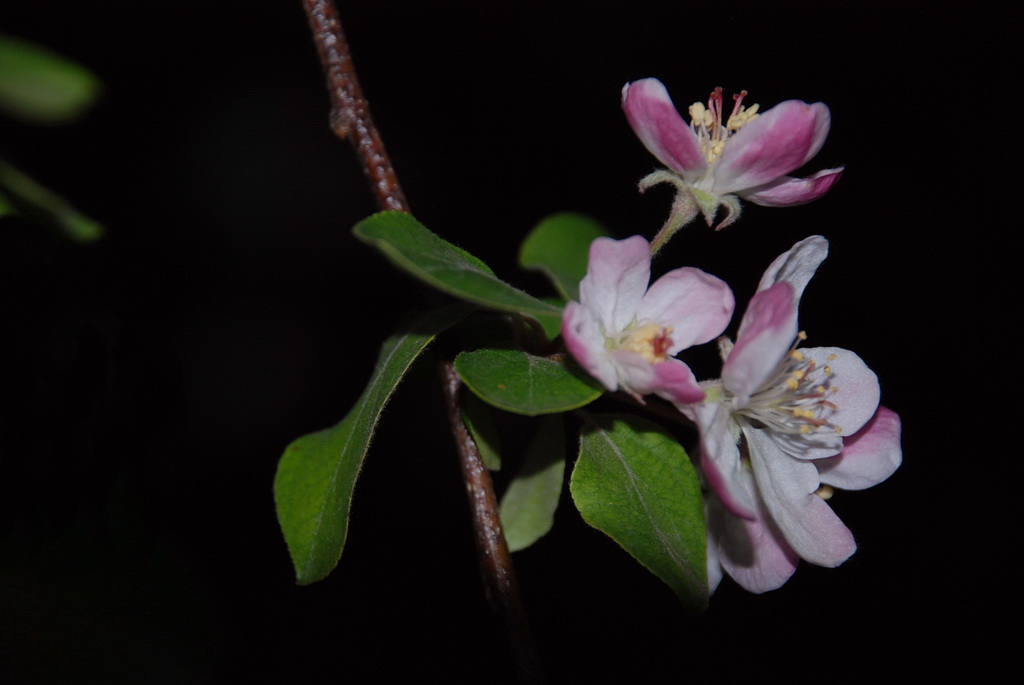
[743,426,857,566]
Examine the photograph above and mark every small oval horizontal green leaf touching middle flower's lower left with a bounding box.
[455,349,604,416]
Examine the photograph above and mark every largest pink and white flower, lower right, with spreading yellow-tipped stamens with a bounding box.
[680,236,902,592]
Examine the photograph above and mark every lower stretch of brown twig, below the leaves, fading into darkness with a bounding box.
[438,360,544,683]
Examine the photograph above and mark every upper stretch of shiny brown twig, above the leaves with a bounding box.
[302,0,409,212]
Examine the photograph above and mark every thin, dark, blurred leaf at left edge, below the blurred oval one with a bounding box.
[0,160,103,243]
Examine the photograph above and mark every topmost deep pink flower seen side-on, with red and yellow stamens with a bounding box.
[623,79,843,235]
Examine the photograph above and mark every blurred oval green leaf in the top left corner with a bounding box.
[0,36,100,124]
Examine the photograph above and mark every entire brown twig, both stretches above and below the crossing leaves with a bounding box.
[302,0,544,683]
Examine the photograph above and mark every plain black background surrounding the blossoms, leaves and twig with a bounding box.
[0,0,1022,683]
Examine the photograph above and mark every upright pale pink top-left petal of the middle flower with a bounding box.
[580,236,650,336]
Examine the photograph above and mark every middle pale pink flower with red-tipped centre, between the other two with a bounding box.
[562,236,735,403]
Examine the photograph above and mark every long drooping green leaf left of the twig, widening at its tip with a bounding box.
[273,304,472,585]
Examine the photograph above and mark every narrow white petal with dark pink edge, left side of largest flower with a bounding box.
[679,402,757,519]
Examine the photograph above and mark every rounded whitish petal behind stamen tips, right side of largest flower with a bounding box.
[800,347,882,438]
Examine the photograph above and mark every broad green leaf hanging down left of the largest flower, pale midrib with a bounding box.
[569,415,708,613]
